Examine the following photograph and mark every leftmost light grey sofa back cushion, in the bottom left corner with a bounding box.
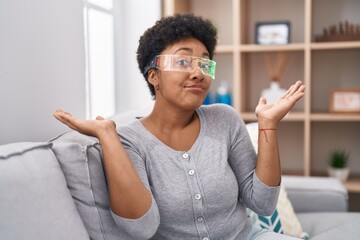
[0,142,89,240]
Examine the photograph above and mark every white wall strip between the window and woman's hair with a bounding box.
[116,0,161,112]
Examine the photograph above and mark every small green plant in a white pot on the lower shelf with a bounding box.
[328,150,350,182]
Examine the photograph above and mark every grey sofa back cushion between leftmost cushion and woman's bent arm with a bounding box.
[51,131,131,240]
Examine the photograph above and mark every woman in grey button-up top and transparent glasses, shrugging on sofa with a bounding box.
[54,14,304,240]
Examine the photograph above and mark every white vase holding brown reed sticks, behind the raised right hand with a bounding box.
[261,52,287,103]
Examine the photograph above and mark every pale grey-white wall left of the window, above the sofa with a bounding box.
[0,0,85,144]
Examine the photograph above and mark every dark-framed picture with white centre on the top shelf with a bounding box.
[255,21,290,45]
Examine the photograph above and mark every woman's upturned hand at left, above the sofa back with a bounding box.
[53,109,116,139]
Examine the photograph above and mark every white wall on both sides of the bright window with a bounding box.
[0,0,160,144]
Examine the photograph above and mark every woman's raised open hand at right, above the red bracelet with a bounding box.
[255,81,305,128]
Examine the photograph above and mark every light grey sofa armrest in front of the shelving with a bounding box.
[282,176,348,213]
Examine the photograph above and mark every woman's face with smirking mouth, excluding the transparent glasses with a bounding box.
[153,38,212,110]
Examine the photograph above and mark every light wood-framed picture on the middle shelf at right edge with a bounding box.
[330,88,360,113]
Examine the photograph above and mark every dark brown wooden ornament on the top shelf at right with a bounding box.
[315,21,360,42]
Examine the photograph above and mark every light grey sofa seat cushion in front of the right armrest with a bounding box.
[297,212,360,240]
